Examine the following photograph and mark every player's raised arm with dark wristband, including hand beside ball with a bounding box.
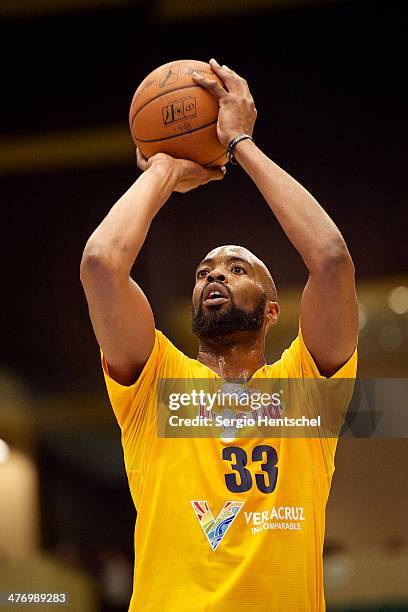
[194,60,358,375]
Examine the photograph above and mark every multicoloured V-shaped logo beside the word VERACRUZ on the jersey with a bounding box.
[191,501,245,550]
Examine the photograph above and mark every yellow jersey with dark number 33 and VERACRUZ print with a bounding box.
[102,330,357,612]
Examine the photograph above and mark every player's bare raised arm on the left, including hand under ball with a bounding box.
[81,152,224,385]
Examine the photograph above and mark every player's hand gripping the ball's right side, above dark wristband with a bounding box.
[193,59,256,147]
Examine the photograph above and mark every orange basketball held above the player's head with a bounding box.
[129,60,227,167]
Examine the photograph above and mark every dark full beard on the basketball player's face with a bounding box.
[191,293,267,338]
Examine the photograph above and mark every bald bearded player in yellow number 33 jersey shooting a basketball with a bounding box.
[81,60,358,612]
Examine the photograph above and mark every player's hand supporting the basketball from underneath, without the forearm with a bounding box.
[136,149,225,193]
